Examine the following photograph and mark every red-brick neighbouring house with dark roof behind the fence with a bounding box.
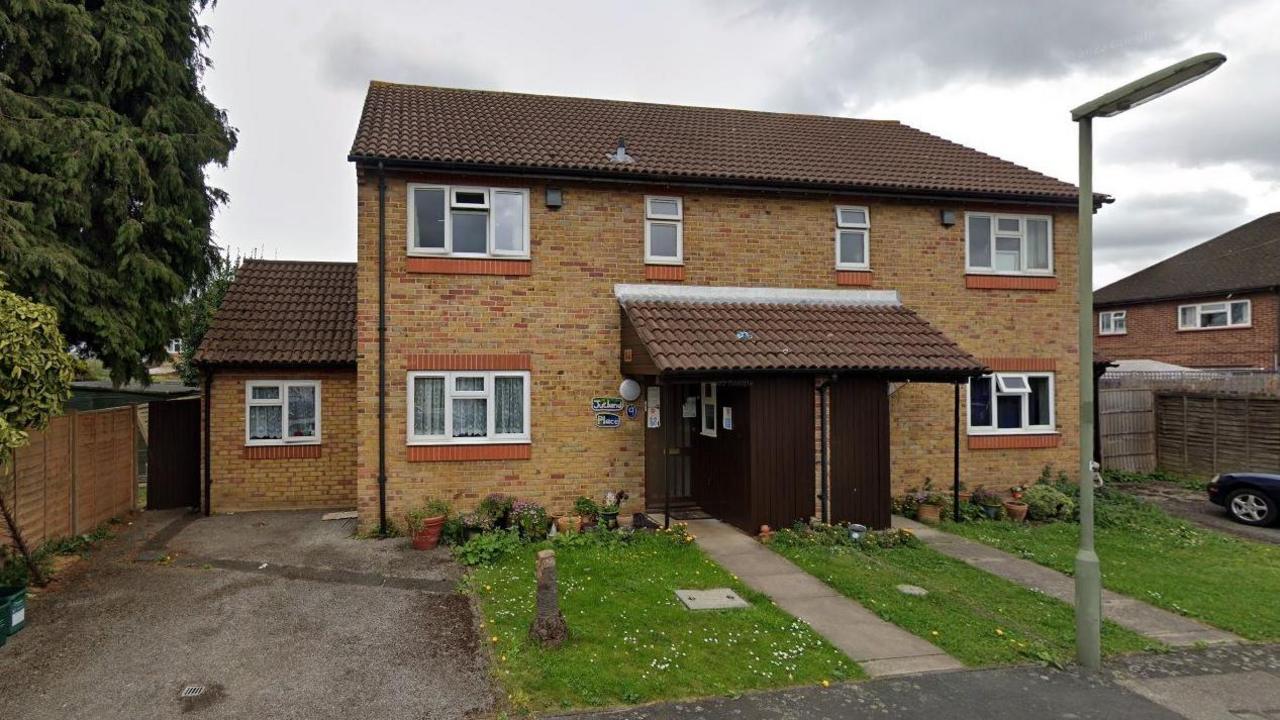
[1093,213,1280,370]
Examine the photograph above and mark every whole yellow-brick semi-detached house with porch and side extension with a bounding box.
[192,82,1079,528]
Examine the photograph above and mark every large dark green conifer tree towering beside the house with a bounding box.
[0,0,236,382]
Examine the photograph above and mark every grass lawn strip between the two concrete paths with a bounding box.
[773,542,1160,665]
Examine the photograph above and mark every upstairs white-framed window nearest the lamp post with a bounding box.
[965,213,1053,275]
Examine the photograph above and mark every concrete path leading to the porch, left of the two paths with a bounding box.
[689,520,961,676]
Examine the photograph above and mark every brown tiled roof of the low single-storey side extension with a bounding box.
[196,260,356,365]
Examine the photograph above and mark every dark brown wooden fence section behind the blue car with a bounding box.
[1156,393,1280,475]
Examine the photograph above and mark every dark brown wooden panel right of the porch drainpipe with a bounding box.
[829,378,890,529]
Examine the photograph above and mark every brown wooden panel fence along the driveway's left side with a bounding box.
[0,406,137,546]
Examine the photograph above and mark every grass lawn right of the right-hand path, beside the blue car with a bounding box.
[943,491,1280,642]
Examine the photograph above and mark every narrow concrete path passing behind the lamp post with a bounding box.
[893,515,1242,647]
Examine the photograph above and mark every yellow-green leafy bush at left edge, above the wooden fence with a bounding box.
[0,275,76,448]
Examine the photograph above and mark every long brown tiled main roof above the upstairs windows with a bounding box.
[349,81,1076,202]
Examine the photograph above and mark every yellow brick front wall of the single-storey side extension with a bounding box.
[210,369,357,512]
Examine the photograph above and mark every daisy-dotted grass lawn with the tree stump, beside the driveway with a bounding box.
[466,533,863,711]
